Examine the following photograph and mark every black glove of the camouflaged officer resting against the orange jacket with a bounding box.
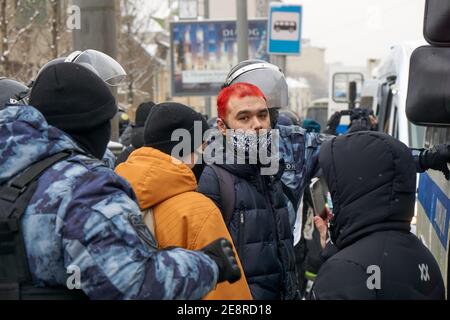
[201,238,241,283]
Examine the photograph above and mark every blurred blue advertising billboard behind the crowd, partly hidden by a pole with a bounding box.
[170,19,269,96]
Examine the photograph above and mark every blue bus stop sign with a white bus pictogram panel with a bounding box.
[268,3,303,55]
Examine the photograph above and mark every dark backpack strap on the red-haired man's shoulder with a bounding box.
[211,164,236,226]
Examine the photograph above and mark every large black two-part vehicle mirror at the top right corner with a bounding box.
[406,0,450,126]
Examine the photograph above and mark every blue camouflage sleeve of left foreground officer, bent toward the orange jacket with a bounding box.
[61,168,218,299]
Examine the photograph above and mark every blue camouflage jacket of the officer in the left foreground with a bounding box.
[0,107,218,299]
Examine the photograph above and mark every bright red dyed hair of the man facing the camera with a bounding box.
[217,82,267,119]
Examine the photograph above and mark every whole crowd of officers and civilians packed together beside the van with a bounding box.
[0,50,450,300]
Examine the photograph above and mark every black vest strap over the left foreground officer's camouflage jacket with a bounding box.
[0,151,71,300]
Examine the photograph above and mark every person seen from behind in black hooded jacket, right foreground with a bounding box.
[310,131,445,300]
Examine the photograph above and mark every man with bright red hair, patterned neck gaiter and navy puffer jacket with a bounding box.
[198,83,299,300]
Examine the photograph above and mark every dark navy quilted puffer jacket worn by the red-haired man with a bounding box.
[198,160,299,300]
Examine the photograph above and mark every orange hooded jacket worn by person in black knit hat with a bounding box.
[116,148,252,300]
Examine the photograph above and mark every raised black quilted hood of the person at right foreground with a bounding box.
[319,131,416,249]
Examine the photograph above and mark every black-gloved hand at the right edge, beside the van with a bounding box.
[419,144,450,180]
